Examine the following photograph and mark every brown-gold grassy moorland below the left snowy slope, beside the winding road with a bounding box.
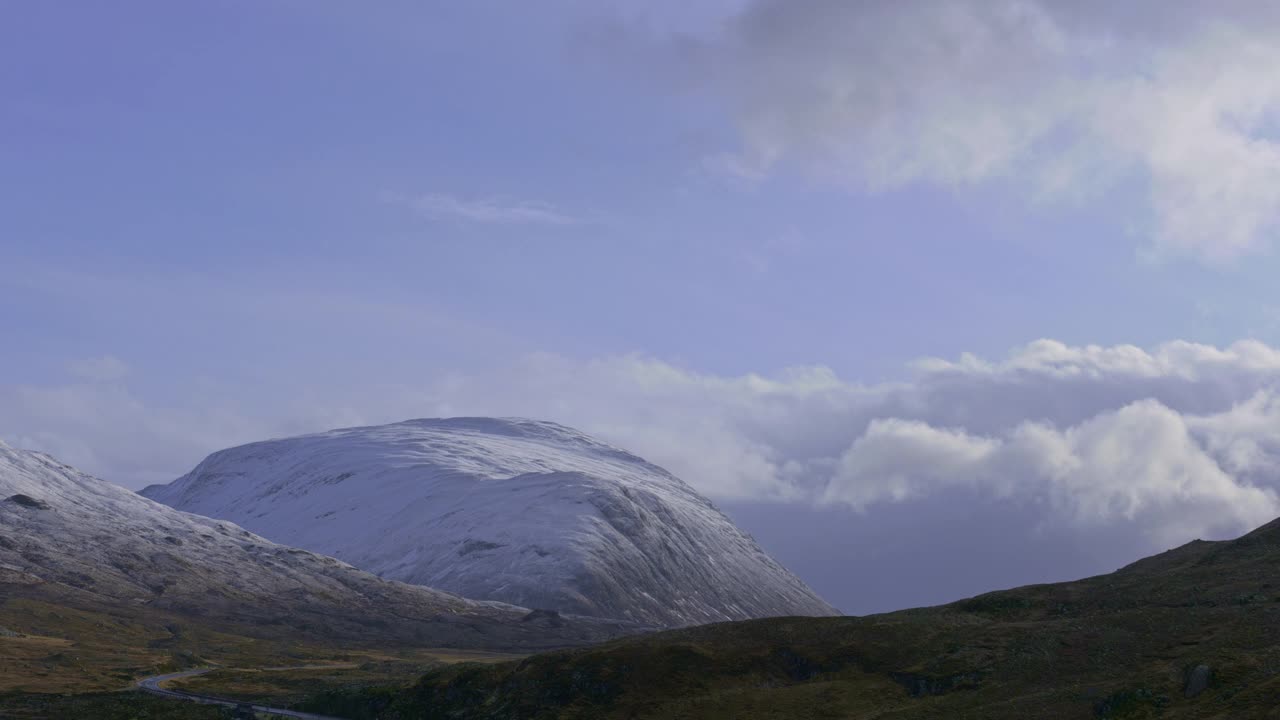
[0,583,524,702]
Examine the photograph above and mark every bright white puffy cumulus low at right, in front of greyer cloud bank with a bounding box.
[822,400,1280,547]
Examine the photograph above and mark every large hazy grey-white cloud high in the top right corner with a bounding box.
[673,0,1280,263]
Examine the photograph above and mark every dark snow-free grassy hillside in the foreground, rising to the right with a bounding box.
[296,521,1280,720]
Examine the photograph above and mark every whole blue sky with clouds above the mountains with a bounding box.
[0,0,1280,614]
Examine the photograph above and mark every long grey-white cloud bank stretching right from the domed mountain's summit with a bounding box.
[381,340,1280,559]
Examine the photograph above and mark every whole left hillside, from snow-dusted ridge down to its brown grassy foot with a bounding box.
[0,435,635,691]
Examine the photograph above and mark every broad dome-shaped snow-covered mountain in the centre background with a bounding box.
[142,418,836,626]
